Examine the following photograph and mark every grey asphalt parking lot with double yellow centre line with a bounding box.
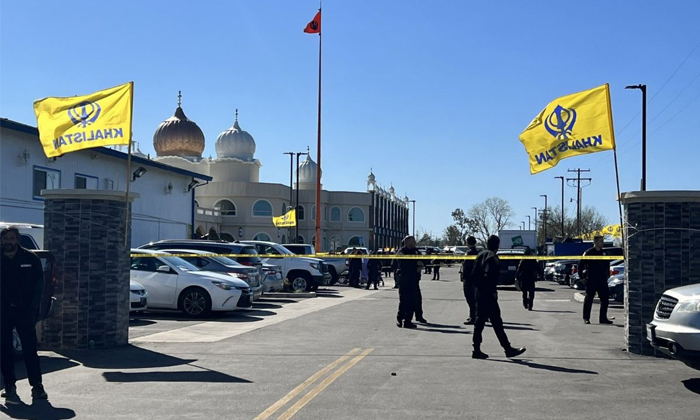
[0,268,700,420]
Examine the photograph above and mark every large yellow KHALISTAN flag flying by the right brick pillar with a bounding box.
[520,83,615,174]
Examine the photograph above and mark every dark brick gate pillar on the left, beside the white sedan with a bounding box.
[42,189,138,350]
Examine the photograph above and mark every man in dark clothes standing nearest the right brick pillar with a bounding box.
[578,235,613,324]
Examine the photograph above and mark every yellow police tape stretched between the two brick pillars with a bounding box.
[131,253,625,261]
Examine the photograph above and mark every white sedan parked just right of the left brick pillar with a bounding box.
[131,249,252,318]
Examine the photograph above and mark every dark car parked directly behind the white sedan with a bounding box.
[162,249,263,301]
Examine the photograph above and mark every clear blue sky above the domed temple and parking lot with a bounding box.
[0,0,700,234]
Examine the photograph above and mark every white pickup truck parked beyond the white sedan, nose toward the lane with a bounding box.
[241,241,331,291]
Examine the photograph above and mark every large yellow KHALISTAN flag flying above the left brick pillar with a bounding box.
[34,82,134,157]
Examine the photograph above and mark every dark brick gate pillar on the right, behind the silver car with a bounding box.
[622,191,700,355]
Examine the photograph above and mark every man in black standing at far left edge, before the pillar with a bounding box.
[0,226,48,402]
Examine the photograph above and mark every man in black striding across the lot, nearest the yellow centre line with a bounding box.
[471,235,525,359]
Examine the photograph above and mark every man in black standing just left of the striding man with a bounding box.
[395,236,423,328]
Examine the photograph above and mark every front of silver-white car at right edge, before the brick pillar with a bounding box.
[647,284,700,370]
